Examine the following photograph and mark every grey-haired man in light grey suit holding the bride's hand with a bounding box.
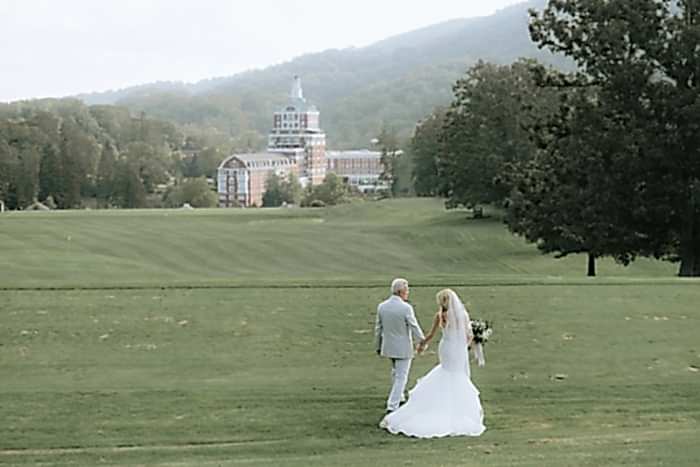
[374,279,425,413]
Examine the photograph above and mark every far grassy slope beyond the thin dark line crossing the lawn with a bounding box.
[0,200,675,287]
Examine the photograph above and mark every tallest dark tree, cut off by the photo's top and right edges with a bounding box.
[531,0,700,276]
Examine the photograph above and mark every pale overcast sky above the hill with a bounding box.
[0,0,521,101]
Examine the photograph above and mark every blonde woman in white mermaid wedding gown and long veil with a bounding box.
[379,289,486,438]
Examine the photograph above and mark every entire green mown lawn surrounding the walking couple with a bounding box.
[0,200,700,467]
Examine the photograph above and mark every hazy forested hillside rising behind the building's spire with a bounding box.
[74,0,562,148]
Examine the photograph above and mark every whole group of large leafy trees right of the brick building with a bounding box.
[410,0,700,276]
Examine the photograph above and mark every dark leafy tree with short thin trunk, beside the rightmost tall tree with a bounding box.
[506,90,650,276]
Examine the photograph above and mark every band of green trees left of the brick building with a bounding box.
[0,99,231,209]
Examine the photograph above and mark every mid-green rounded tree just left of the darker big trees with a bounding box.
[438,61,557,207]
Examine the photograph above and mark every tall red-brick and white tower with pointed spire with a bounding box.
[267,76,326,185]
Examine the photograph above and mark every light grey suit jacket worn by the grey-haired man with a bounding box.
[374,295,425,358]
